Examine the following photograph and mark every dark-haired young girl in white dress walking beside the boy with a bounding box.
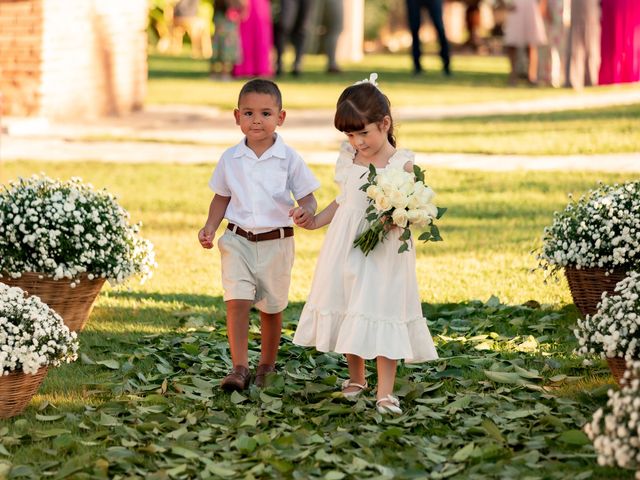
[291,75,438,413]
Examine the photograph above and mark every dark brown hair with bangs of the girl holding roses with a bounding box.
[333,82,396,147]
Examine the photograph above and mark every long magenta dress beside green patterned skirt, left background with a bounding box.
[232,0,273,77]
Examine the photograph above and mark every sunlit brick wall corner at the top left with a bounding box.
[0,0,147,118]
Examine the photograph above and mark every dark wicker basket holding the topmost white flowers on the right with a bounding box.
[564,267,626,316]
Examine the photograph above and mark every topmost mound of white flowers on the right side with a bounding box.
[537,182,640,274]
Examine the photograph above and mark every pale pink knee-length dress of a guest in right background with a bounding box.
[504,0,547,47]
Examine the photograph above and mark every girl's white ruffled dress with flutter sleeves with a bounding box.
[293,143,438,363]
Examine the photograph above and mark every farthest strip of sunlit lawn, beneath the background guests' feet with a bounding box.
[146,53,637,110]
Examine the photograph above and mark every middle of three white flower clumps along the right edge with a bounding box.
[574,272,640,360]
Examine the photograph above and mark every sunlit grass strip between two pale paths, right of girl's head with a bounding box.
[398,104,640,155]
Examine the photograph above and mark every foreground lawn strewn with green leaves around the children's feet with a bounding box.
[0,162,633,479]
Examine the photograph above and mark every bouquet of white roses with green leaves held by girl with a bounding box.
[353,165,447,255]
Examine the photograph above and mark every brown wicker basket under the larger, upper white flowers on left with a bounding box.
[0,273,104,332]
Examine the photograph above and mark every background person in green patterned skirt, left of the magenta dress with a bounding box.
[210,0,246,80]
